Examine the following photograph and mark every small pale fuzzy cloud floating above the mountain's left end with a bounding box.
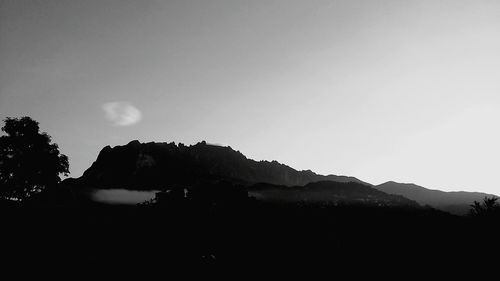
[102,101,142,127]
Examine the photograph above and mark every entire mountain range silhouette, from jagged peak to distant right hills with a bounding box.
[62,140,495,215]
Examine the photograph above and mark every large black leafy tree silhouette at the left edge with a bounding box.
[0,117,69,200]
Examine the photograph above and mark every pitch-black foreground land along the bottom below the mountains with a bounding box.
[0,198,500,275]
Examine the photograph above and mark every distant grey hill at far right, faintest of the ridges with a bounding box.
[374,181,497,215]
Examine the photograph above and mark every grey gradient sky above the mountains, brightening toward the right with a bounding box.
[0,0,500,194]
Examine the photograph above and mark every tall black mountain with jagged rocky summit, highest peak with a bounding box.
[76,141,369,190]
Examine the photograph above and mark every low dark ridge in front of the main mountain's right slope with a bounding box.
[248,181,419,208]
